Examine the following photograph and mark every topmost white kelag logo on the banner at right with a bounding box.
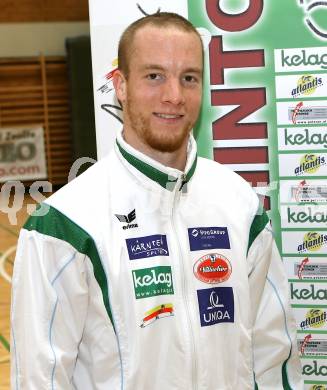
[281,49,327,70]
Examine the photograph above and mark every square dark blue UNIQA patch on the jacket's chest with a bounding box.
[197,287,234,326]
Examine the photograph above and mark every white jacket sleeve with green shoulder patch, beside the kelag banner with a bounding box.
[248,211,304,390]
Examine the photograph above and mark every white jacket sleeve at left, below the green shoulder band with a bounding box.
[11,229,88,390]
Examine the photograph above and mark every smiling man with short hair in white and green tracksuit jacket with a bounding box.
[12,13,303,390]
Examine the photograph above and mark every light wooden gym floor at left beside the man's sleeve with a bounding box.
[0,196,35,390]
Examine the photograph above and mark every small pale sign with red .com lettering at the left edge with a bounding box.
[0,126,47,183]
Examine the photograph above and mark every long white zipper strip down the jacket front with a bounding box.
[172,174,198,390]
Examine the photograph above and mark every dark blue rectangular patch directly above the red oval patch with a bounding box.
[187,227,230,251]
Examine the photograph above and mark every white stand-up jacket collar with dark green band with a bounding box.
[116,131,197,191]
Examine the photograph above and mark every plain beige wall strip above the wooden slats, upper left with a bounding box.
[0,22,90,57]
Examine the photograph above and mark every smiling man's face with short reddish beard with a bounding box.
[116,26,203,152]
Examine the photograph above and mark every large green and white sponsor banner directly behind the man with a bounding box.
[90,0,327,390]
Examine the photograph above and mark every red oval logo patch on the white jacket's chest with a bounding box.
[193,253,232,283]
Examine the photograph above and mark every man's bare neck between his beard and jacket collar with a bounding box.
[123,130,188,172]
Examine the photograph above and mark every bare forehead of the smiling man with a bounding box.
[129,25,202,69]
